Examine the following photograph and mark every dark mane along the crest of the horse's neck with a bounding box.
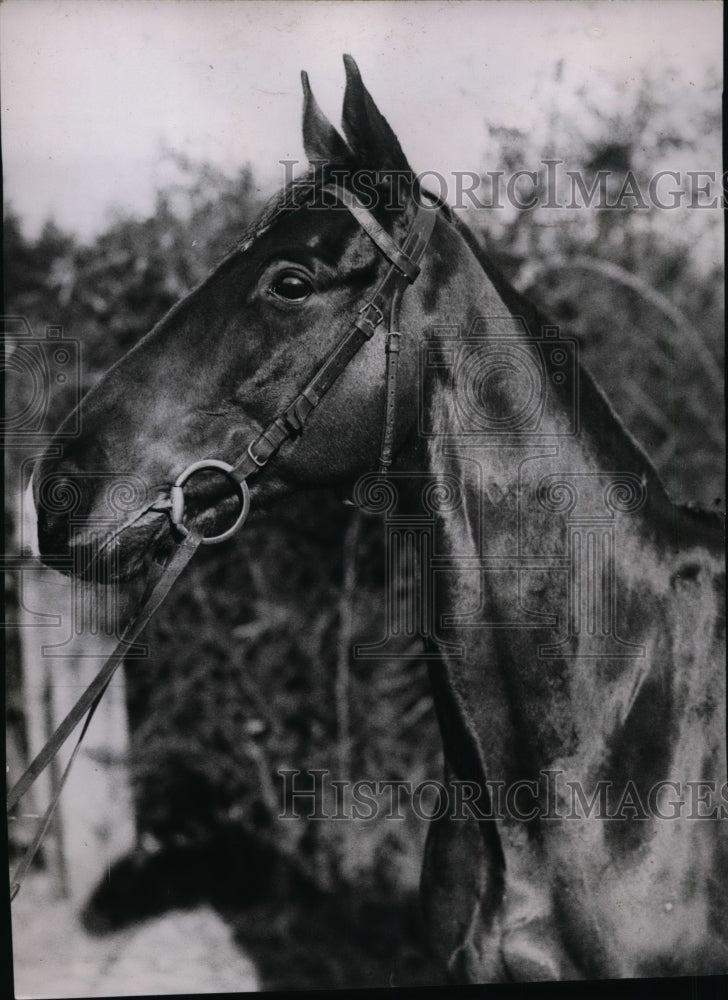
[450,214,724,544]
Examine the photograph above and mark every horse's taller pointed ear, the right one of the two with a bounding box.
[342,56,411,172]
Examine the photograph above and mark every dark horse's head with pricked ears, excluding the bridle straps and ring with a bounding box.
[34,57,478,576]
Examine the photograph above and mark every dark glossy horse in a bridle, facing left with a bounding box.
[33,56,728,983]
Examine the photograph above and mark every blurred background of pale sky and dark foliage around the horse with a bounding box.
[0,0,724,995]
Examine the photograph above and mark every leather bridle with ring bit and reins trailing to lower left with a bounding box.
[7,185,442,899]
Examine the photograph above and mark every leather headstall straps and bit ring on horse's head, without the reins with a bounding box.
[170,185,438,545]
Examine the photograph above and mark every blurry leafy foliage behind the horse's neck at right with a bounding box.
[478,65,725,506]
